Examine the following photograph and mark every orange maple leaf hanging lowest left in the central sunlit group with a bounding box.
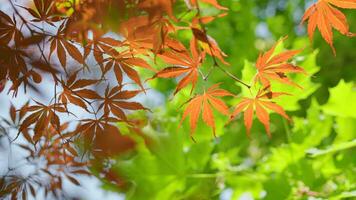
[180,84,234,136]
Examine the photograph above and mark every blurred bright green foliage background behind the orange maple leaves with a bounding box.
[0,0,356,200]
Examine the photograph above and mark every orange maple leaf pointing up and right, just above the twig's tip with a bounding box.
[254,37,306,88]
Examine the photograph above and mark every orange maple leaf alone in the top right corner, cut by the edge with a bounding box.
[301,0,356,54]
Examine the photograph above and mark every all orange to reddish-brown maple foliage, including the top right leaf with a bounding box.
[0,0,355,199]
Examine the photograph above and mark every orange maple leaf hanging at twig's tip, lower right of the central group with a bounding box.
[230,87,290,137]
